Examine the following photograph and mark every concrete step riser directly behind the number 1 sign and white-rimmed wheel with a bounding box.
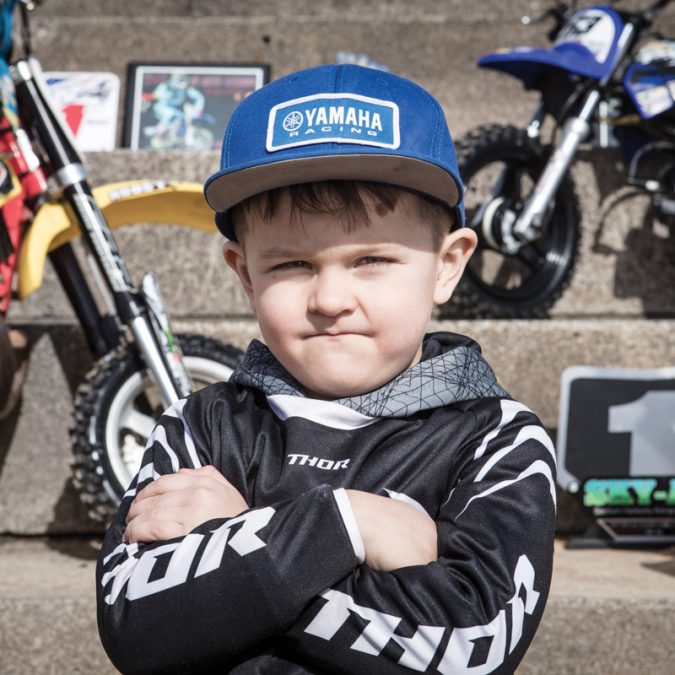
[0,319,675,534]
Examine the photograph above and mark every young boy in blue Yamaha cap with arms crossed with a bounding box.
[97,66,555,674]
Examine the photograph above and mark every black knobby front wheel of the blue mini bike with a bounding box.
[441,125,581,318]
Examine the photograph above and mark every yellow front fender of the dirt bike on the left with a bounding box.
[18,180,216,299]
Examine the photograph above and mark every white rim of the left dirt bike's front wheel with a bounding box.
[105,356,233,489]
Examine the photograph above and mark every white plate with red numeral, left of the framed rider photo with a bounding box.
[44,72,120,152]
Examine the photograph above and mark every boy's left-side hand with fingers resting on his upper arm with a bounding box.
[124,466,248,543]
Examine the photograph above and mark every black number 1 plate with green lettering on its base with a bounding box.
[557,366,675,544]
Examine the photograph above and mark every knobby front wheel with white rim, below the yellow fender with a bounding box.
[71,335,243,523]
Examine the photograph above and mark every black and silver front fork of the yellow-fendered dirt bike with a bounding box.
[12,57,192,406]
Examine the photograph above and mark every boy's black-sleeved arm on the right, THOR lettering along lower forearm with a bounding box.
[287,402,555,673]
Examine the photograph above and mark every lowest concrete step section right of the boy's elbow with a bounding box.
[518,541,675,675]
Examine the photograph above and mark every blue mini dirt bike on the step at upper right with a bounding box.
[457,0,675,317]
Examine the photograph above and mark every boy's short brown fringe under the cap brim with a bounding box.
[230,180,456,249]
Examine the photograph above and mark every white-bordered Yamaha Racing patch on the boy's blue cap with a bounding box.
[266,94,401,152]
